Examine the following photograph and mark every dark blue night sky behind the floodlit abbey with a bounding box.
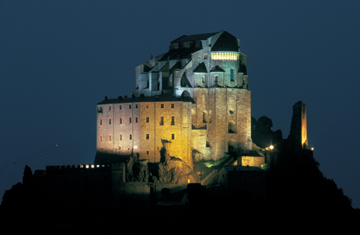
[0,0,360,208]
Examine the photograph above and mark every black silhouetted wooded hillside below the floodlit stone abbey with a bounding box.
[0,115,360,234]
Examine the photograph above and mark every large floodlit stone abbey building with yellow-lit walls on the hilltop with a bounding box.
[96,31,252,167]
